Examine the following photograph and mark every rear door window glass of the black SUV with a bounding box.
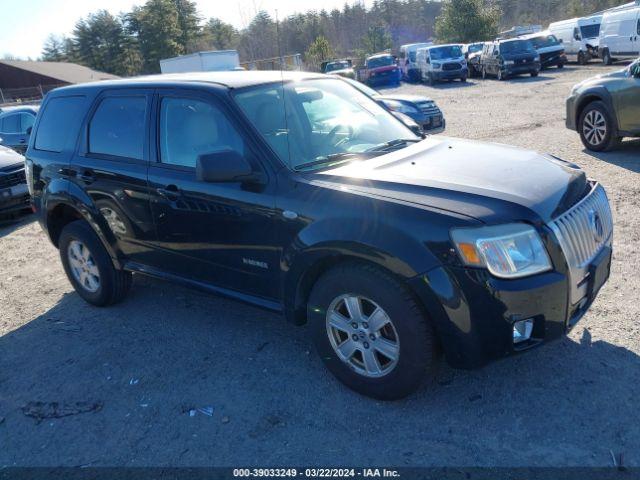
[89,96,147,160]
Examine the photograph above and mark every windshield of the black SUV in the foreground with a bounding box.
[235,79,421,169]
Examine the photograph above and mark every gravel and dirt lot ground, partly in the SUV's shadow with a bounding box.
[0,65,640,467]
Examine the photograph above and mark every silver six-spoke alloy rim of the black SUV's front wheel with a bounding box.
[326,294,400,378]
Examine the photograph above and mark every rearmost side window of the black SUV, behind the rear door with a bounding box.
[35,96,85,152]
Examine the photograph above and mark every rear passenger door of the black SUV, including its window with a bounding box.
[68,89,155,264]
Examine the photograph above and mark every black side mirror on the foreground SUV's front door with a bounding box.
[196,150,257,183]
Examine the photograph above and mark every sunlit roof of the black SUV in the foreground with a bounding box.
[50,70,327,92]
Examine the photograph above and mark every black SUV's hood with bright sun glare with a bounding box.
[316,137,587,223]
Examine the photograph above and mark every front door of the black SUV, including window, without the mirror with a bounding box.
[149,89,279,298]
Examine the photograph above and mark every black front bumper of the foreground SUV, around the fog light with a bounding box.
[411,244,610,369]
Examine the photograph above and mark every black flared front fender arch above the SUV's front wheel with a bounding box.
[282,218,440,324]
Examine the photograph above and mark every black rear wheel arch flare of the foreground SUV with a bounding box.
[41,179,122,268]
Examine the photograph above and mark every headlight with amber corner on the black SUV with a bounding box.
[451,223,552,278]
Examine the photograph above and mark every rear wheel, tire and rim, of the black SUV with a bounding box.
[58,220,131,307]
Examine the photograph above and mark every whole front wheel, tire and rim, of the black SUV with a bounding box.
[307,263,438,400]
